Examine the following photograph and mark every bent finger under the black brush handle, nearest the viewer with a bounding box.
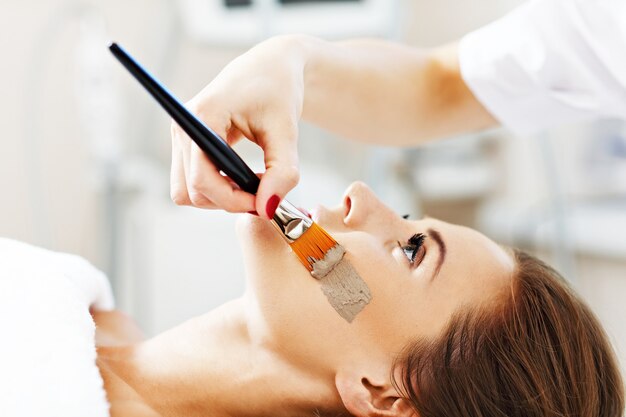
[187,143,255,213]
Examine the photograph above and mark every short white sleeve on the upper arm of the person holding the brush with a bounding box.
[459,0,626,134]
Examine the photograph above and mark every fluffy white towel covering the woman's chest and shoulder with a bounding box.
[0,239,113,417]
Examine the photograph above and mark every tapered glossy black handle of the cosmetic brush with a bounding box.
[109,43,260,194]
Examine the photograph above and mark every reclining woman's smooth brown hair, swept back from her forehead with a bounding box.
[394,250,624,417]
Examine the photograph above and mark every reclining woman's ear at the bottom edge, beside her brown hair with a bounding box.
[335,372,417,417]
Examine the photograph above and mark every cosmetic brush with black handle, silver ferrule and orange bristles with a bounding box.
[109,43,345,279]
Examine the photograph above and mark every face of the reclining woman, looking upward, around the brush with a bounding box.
[238,183,514,370]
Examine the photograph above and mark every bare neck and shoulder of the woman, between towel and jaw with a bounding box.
[98,300,340,417]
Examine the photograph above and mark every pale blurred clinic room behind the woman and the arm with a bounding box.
[0,0,626,374]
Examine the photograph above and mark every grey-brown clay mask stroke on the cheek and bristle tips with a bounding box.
[311,245,372,323]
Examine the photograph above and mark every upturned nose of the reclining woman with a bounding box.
[343,181,397,229]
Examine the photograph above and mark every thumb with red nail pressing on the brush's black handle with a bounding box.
[256,126,300,219]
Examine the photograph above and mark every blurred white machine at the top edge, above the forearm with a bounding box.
[180,0,400,45]
